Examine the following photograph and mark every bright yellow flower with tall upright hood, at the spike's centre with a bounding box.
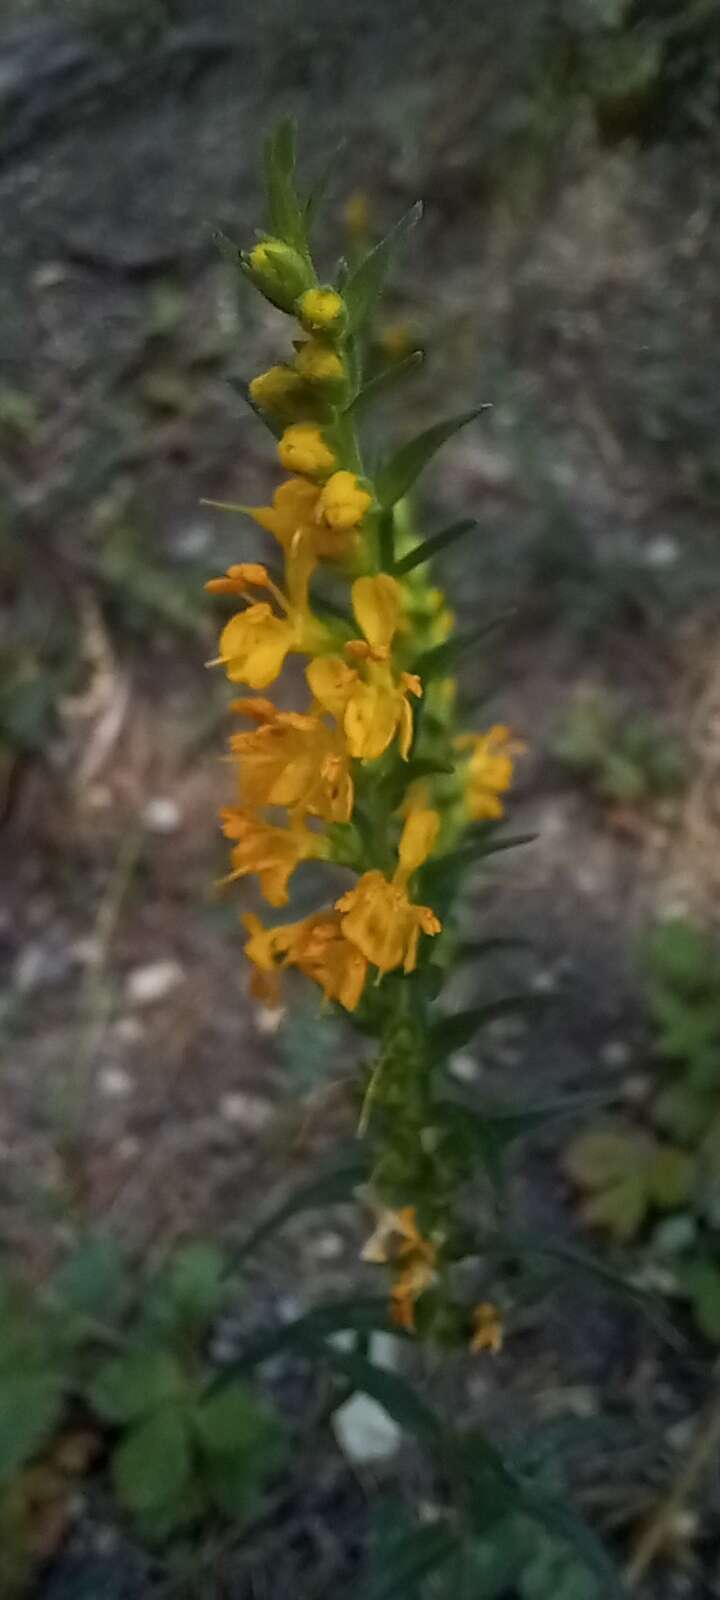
[306,573,422,762]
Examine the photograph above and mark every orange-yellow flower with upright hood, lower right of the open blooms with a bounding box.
[336,811,442,974]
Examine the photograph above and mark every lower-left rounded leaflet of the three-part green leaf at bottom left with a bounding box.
[112,1406,192,1514]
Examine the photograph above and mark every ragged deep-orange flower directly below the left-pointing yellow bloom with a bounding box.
[230,701,354,822]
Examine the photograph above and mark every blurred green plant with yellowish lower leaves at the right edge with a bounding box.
[565,918,720,1342]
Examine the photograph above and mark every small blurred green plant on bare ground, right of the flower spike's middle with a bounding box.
[552,688,686,816]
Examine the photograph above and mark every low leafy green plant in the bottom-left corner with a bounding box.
[0,1240,283,1594]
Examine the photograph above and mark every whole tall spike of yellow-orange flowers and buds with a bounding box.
[208,124,520,1349]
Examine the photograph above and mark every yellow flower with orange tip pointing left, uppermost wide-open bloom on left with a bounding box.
[205,563,328,690]
